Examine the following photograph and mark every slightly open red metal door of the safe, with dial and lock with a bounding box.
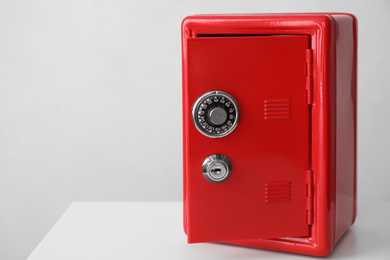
[183,35,310,243]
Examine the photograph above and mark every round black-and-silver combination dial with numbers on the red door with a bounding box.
[192,91,239,138]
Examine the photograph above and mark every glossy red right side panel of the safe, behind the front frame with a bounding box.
[334,15,357,241]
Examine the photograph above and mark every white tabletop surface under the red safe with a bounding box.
[28,202,390,260]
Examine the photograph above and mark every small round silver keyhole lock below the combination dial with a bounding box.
[202,154,232,183]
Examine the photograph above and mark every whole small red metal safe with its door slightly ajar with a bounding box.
[182,13,357,256]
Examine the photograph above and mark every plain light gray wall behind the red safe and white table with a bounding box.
[0,0,390,259]
